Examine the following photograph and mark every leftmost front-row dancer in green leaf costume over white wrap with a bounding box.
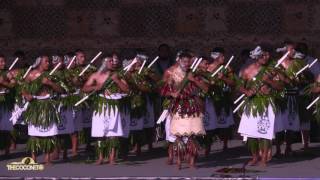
[22,55,63,164]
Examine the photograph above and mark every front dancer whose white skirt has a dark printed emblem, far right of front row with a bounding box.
[238,46,281,165]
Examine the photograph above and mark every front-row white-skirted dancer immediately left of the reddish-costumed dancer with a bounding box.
[82,55,129,164]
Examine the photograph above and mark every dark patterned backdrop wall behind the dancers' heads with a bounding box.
[0,0,320,64]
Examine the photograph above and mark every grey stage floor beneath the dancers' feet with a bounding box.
[0,140,320,179]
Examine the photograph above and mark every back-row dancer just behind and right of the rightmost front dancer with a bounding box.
[276,42,313,156]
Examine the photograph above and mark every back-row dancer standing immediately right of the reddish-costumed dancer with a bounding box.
[206,47,235,153]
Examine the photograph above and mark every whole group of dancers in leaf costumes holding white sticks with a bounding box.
[0,42,320,169]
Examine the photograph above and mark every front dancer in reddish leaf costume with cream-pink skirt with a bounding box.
[161,50,208,169]
